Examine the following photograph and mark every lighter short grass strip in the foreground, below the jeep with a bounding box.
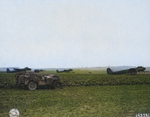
[0,85,150,117]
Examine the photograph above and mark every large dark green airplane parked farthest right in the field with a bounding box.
[107,66,146,75]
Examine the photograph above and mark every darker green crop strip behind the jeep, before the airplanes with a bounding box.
[0,72,150,88]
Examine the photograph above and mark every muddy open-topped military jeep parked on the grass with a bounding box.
[15,71,62,90]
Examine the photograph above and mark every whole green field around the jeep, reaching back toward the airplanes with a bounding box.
[0,69,150,117]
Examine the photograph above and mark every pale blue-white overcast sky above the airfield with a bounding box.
[0,0,150,68]
